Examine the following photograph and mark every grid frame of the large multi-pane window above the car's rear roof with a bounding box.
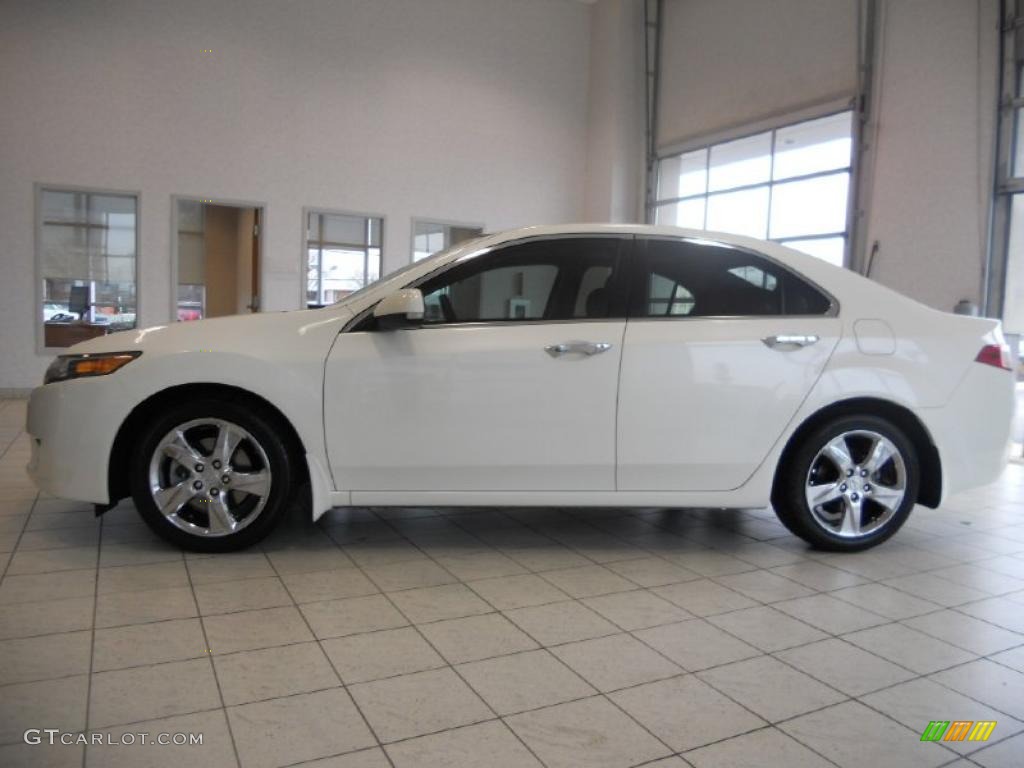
[647,109,859,268]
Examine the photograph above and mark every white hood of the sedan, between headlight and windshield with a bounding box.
[67,305,351,354]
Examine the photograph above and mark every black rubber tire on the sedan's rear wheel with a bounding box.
[772,415,921,552]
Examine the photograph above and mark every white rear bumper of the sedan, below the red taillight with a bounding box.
[919,364,1016,501]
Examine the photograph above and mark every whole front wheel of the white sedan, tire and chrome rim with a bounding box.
[131,399,291,552]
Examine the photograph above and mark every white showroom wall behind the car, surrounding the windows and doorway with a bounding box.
[0,0,998,391]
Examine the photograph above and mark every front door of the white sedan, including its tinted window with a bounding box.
[325,236,632,495]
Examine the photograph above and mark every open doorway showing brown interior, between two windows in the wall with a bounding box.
[174,198,263,322]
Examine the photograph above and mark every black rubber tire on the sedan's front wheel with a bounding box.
[129,397,294,552]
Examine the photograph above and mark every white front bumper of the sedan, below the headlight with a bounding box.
[26,377,125,504]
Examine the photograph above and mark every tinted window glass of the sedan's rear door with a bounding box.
[632,240,829,317]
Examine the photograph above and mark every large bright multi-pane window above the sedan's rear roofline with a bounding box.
[653,112,853,266]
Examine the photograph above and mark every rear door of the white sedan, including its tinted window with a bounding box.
[617,239,841,490]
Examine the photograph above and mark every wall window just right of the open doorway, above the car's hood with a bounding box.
[306,211,384,307]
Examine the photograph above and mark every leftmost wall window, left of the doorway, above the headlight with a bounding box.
[37,188,138,347]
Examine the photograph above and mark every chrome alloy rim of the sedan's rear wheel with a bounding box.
[804,429,906,539]
